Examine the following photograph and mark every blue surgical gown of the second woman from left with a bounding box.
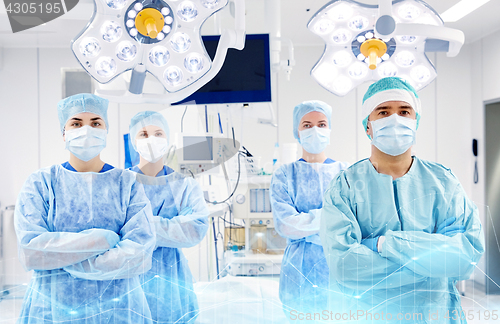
[132,166,209,323]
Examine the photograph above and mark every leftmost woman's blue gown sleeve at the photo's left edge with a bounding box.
[14,171,120,271]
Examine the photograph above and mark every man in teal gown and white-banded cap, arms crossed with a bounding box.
[321,77,484,323]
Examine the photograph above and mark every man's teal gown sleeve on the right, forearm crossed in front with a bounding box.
[381,184,484,280]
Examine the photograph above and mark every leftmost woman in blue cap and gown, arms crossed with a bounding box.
[15,94,155,324]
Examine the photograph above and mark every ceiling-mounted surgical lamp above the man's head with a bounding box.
[308,0,465,96]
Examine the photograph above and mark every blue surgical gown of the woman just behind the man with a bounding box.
[270,159,347,313]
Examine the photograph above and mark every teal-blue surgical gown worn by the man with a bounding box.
[321,157,484,323]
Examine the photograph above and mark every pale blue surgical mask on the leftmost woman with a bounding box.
[65,126,107,162]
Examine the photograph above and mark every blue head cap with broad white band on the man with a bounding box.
[361,77,422,135]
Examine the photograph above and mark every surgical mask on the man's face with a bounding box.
[371,114,417,156]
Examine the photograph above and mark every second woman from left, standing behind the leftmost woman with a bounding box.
[130,111,209,323]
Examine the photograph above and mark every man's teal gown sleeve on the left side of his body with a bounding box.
[320,173,426,291]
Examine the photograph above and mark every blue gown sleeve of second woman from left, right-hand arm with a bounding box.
[153,178,210,248]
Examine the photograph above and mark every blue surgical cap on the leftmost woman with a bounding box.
[57,93,109,134]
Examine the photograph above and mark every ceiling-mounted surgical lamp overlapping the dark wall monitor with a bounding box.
[71,0,245,103]
